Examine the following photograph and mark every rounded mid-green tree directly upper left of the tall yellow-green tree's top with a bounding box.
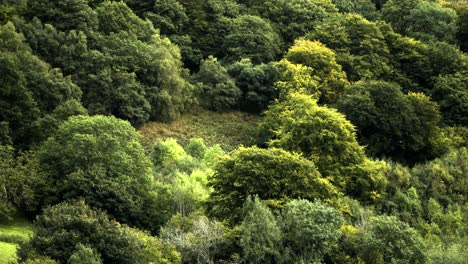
[223,15,281,64]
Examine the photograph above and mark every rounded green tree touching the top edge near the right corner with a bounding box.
[382,0,458,42]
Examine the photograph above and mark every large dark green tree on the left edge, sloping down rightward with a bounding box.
[0,22,83,149]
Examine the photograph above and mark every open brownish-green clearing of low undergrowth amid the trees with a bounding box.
[139,110,260,151]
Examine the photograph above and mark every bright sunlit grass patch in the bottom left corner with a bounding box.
[0,217,32,264]
